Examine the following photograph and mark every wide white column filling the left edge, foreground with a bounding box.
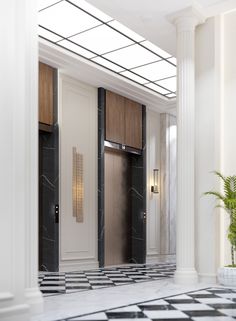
[0,0,42,321]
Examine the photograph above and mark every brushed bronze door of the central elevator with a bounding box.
[105,150,131,266]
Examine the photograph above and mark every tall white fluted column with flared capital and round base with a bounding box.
[171,7,203,284]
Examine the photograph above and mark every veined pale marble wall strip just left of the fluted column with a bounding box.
[160,114,176,258]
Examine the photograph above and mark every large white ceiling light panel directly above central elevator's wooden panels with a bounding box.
[104,45,160,69]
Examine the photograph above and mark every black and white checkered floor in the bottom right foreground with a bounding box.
[57,287,236,321]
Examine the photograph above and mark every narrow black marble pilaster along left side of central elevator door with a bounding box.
[98,88,106,267]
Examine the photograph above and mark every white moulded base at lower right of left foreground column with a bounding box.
[25,287,43,314]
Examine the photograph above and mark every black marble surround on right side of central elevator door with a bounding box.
[131,106,146,263]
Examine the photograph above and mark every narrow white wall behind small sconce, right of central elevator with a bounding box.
[146,108,160,262]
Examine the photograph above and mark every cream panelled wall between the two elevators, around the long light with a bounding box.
[59,75,98,271]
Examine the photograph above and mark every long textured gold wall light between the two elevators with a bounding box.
[72,147,84,223]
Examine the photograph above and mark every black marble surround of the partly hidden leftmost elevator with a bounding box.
[39,70,59,271]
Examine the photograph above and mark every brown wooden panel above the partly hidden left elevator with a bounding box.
[39,62,54,125]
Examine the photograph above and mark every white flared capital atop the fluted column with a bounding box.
[167,6,206,31]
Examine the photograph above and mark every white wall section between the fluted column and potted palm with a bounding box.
[195,18,221,282]
